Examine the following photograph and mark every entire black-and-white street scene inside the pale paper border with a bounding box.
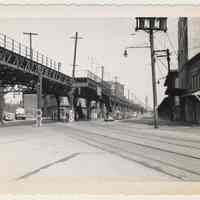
[0,5,200,195]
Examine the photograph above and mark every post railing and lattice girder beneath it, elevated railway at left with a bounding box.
[0,33,72,86]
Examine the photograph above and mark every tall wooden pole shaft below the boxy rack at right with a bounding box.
[149,30,158,128]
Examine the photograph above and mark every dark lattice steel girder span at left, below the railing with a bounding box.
[0,47,72,94]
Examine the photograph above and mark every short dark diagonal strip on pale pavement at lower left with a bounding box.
[15,153,81,181]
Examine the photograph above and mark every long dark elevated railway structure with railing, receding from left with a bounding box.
[0,33,141,122]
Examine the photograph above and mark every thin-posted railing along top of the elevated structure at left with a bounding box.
[0,33,61,71]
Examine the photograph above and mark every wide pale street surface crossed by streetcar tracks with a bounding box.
[0,120,200,181]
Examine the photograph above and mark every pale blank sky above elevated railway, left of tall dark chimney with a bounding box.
[0,18,177,106]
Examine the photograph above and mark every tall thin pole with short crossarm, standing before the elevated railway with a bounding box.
[70,32,82,121]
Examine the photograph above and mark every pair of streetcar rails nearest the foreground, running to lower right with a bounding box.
[59,125,200,180]
